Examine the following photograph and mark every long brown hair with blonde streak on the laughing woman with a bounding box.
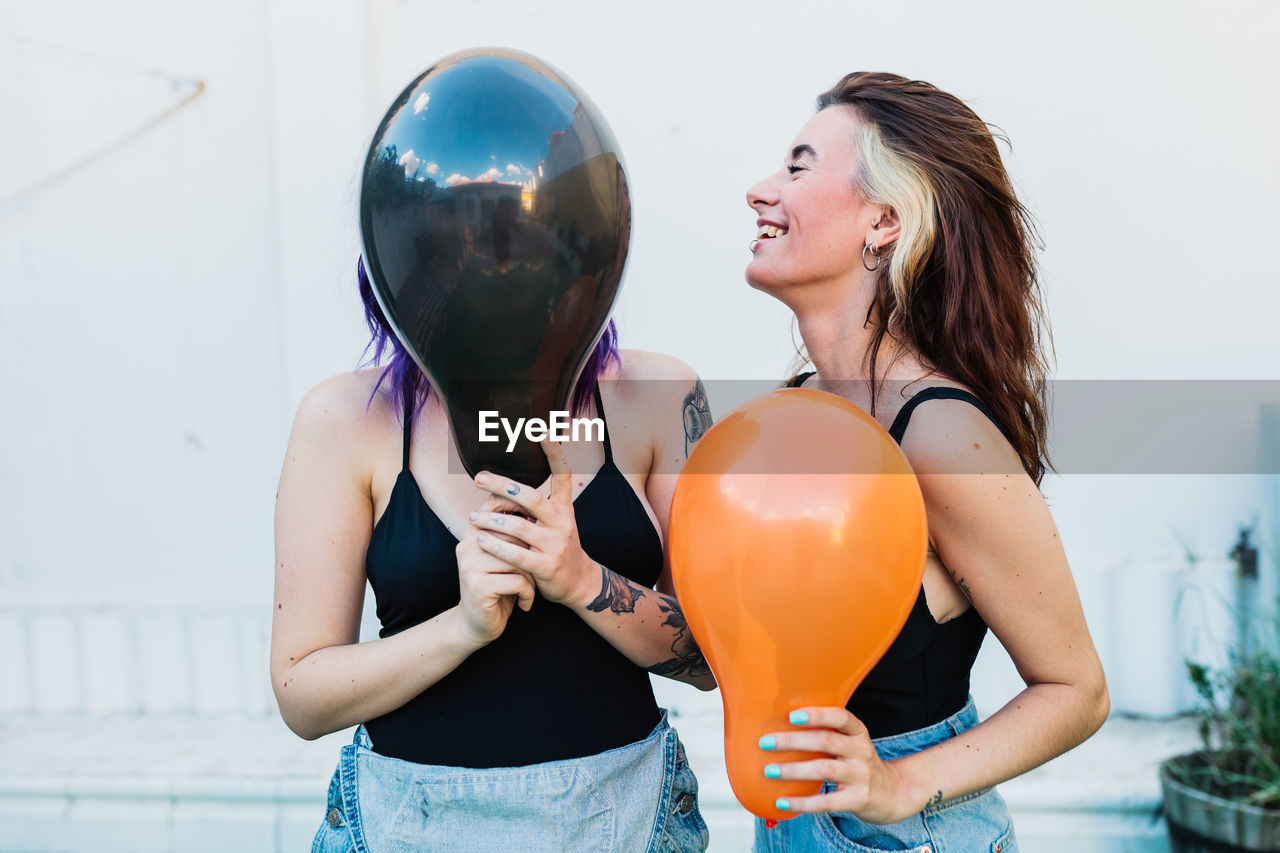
[798,72,1052,483]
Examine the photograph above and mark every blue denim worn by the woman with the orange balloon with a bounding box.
[753,699,1018,853]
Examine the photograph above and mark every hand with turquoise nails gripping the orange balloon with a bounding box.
[760,707,927,824]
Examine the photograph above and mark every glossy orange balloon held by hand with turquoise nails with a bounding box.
[669,388,928,820]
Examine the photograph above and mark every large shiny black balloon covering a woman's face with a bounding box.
[360,47,631,484]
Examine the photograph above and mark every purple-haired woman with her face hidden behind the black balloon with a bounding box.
[271,264,714,853]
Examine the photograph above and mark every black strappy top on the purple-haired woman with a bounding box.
[365,388,662,767]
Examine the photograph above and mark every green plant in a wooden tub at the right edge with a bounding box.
[1160,530,1280,853]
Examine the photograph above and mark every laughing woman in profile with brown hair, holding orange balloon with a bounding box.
[746,73,1110,853]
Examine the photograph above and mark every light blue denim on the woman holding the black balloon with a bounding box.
[311,711,708,853]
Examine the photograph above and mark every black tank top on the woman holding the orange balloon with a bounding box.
[787,373,1004,738]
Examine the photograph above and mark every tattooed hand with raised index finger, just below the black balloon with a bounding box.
[471,441,602,605]
